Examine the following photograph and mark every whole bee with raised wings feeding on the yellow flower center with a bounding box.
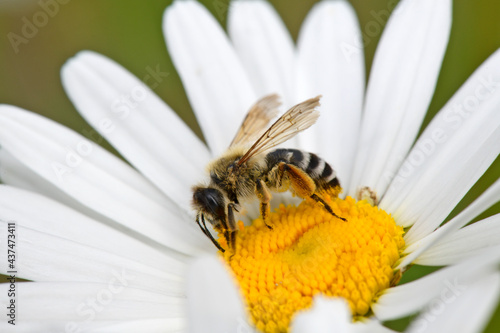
[192,95,345,252]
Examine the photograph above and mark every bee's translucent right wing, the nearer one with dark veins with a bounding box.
[238,96,321,164]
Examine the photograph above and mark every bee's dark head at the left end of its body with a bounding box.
[192,186,226,220]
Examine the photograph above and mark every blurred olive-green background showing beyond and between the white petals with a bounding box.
[0,0,500,332]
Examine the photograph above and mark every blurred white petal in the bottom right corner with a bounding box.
[408,273,500,333]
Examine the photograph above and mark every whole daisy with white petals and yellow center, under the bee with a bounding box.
[0,0,500,333]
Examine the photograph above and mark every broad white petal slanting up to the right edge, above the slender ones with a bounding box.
[380,51,500,244]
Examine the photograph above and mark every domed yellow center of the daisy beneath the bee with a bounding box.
[220,195,404,333]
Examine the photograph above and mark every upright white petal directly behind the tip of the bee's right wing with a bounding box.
[296,1,365,189]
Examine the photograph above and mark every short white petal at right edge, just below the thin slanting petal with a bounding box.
[414,214,500,266]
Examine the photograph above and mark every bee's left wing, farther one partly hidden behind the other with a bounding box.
[229,94,281,147]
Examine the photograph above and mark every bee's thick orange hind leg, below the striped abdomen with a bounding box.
[279,162,346,221]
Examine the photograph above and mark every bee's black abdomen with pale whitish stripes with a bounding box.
[266,149,340,189]
